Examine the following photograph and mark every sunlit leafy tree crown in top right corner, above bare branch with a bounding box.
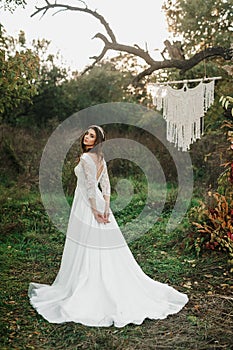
[164,0,233,54]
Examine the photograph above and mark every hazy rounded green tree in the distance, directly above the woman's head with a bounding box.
[34,58,141,125]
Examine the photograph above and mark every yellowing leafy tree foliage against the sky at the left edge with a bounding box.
[0,27,39,122]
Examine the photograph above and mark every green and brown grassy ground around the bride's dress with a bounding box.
[0,185,233,350]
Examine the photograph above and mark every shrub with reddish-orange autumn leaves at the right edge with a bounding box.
[190,91,233,272]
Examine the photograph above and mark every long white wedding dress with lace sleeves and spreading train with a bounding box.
[28,153,188,327]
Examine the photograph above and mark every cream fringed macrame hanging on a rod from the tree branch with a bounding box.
[148,77,221,151]
